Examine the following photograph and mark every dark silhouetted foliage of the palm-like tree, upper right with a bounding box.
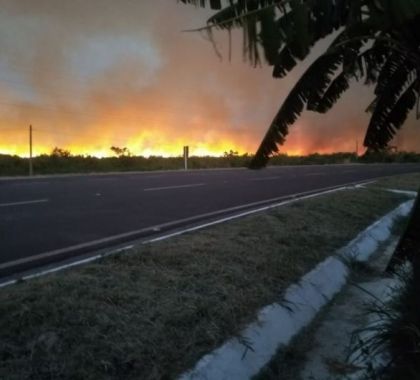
[180,0,420,168]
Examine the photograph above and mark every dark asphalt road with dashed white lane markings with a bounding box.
[0,164,420,274]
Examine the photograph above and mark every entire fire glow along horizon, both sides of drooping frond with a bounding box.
[0,119,364,158]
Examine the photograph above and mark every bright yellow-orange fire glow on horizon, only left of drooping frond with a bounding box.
[0,121,255,157]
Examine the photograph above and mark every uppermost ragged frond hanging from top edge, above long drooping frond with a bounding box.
[186,0,355,71]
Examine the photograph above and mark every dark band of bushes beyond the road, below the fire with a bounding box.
[0,151,420,176]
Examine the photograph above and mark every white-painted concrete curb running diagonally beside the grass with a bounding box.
[179,200,414,380]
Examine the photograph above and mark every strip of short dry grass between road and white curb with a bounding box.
[0,189,407,380]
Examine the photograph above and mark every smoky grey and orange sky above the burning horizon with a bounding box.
[0,0,420,156]
